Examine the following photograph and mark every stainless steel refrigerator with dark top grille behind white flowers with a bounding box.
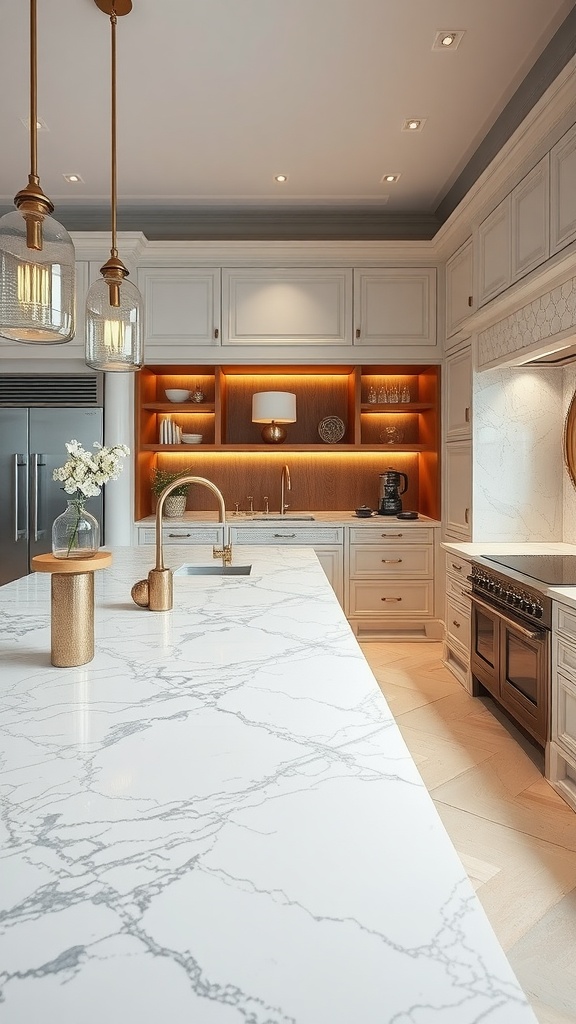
[0,375,104,585]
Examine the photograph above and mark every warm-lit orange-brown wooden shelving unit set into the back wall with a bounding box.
[135,365,440,518]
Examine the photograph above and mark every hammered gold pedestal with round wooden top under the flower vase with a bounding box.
[31,551,112,669]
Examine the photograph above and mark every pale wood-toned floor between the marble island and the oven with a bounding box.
[362,643,576,1024]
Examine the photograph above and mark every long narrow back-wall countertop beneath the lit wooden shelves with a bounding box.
[134,509,442,529]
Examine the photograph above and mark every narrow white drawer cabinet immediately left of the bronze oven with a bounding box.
[444,552,471,693]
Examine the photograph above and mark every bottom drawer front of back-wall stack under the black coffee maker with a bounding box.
[349,580,434,618]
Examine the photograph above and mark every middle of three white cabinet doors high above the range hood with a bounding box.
[511,154,545,282]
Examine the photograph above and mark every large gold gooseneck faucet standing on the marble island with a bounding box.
[131,473,232,611]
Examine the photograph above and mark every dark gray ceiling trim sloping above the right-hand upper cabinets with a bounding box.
[436,5,576,224]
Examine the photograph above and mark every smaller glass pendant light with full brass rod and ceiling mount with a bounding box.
[86,0,143,371]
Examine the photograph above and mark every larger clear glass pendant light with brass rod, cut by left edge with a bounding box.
[0,0,75,345]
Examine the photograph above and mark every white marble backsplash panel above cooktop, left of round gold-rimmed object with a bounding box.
[472,367,561,541]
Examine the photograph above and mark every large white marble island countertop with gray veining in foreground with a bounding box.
[0,547,536,1024]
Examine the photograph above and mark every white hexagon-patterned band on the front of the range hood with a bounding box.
[478,278,576,367]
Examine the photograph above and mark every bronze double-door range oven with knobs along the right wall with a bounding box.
[468,562,551,748]
